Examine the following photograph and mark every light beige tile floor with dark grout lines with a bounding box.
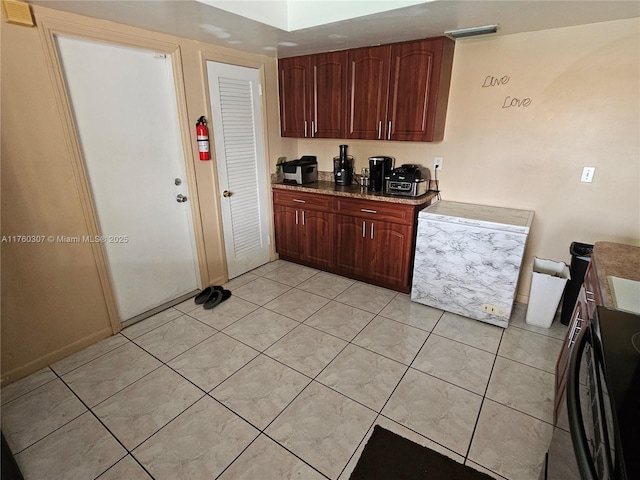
[1,261,566,480]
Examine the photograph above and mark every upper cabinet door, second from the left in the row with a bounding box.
[309,50,347,138]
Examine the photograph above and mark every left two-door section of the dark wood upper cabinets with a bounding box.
[278,51,347,138]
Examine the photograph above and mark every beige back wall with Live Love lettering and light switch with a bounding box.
[298,19,640,301]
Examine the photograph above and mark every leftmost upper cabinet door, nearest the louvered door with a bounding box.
[278,56,311,138]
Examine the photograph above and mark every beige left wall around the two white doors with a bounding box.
[0,7,295,384]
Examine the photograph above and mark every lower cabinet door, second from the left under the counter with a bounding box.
[298,210,334,268]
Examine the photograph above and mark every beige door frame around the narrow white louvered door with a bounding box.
[200,49,275,280]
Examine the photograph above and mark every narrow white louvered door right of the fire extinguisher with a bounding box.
[207,61,269,278]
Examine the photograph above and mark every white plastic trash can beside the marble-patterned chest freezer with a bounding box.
[525,257,571,328]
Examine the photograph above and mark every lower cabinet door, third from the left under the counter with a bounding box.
[334,215,366,275]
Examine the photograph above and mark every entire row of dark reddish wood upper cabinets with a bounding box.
[278,37,455,142]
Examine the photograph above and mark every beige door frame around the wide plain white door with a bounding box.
[38,16,209,334]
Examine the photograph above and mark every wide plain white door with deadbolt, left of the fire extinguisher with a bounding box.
[56,36,200,322]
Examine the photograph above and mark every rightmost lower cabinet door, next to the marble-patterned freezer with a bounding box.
[366,222,412,288]
